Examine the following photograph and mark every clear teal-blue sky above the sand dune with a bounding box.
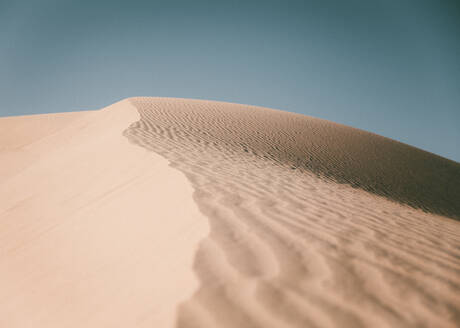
[0,0,460,161]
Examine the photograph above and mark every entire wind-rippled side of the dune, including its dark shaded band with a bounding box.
[124,98,460,327]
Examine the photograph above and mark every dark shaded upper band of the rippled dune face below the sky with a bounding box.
[126,98,460,220]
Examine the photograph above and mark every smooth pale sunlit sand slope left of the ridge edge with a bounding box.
[0,102,208,328]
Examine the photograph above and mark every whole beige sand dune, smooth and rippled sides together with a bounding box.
[0,98,460,328]
